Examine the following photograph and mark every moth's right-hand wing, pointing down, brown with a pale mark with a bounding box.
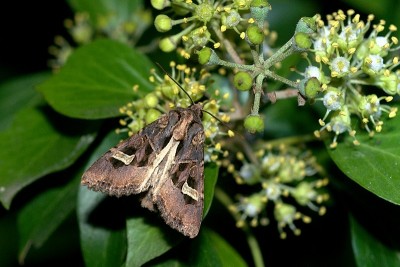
[152,123,204,238]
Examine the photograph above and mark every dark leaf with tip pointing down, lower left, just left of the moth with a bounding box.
[17,171,80,262]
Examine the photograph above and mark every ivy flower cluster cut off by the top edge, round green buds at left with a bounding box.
[151,0,270,59]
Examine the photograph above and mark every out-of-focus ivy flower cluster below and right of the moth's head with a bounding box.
[227,146,329,239]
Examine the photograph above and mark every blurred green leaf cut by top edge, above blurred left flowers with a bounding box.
[68,0,143,24]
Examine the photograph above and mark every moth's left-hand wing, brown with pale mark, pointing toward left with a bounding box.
[81,113,179,196]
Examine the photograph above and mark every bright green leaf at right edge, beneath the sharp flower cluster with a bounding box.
[326,108,400,205]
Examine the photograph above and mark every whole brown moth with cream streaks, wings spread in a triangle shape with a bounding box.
[82,104,204,238]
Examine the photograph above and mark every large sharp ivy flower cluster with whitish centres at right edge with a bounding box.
[300,10,400,148]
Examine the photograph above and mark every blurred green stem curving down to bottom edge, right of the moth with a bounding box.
[215,187,265,267]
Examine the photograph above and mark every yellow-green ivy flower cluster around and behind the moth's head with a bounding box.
[117,62,234,162]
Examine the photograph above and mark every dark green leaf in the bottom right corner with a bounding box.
[350,216,400,267]
